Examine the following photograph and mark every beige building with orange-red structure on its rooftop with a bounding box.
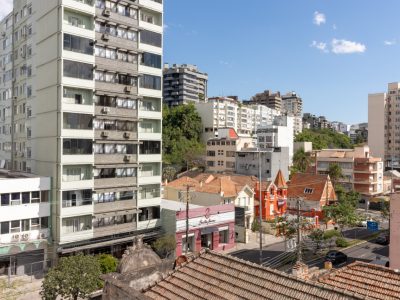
[206,128,252,173]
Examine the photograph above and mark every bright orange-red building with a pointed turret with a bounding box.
[254,171,287,220]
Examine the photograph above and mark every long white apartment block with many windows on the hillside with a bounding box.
[195,96,280,141]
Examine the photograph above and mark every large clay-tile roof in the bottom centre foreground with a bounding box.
[144,250,364,300]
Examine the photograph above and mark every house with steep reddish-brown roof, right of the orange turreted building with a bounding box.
[287,173,337,225]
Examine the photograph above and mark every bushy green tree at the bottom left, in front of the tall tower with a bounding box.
[40,254,101,300]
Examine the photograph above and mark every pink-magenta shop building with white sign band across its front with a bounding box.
[161,200,235,256]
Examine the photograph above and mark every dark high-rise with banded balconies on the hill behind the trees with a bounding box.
[163,64,208,106]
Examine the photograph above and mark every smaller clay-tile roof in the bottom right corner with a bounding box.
[318,261,400,300]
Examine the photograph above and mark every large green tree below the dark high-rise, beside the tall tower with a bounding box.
[163,104,205,167]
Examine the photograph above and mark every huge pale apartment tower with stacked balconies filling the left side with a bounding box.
[0,0,163,255]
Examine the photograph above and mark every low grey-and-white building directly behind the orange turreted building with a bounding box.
[236,147,289,181]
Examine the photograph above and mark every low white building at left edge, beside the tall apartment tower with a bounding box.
[0,171,52,274]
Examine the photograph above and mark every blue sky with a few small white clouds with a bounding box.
[164,0,400,123]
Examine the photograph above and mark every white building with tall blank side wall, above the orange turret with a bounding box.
[256,116,294,165]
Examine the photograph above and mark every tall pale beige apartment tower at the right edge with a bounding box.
[368,82,400,169]
